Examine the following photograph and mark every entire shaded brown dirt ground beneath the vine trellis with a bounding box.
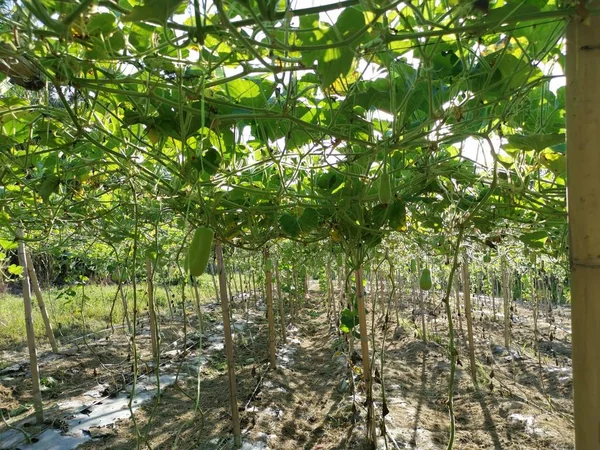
[0,293,574,450]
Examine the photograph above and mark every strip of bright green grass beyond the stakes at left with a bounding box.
[0,274,215,351]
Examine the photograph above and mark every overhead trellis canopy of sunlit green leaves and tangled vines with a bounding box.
[0,0,582,258]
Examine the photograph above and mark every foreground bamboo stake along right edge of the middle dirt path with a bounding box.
[355,267,376,448]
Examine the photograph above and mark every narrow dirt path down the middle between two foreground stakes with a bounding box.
[239,309,352,450]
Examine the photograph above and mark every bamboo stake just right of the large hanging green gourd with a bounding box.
[215,240,242,448]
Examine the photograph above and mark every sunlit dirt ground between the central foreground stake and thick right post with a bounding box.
[376,296,574,450]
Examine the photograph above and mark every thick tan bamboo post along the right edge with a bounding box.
[566,8,600,450]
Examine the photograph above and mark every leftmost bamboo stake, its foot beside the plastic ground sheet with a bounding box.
[17,228,44,423]
